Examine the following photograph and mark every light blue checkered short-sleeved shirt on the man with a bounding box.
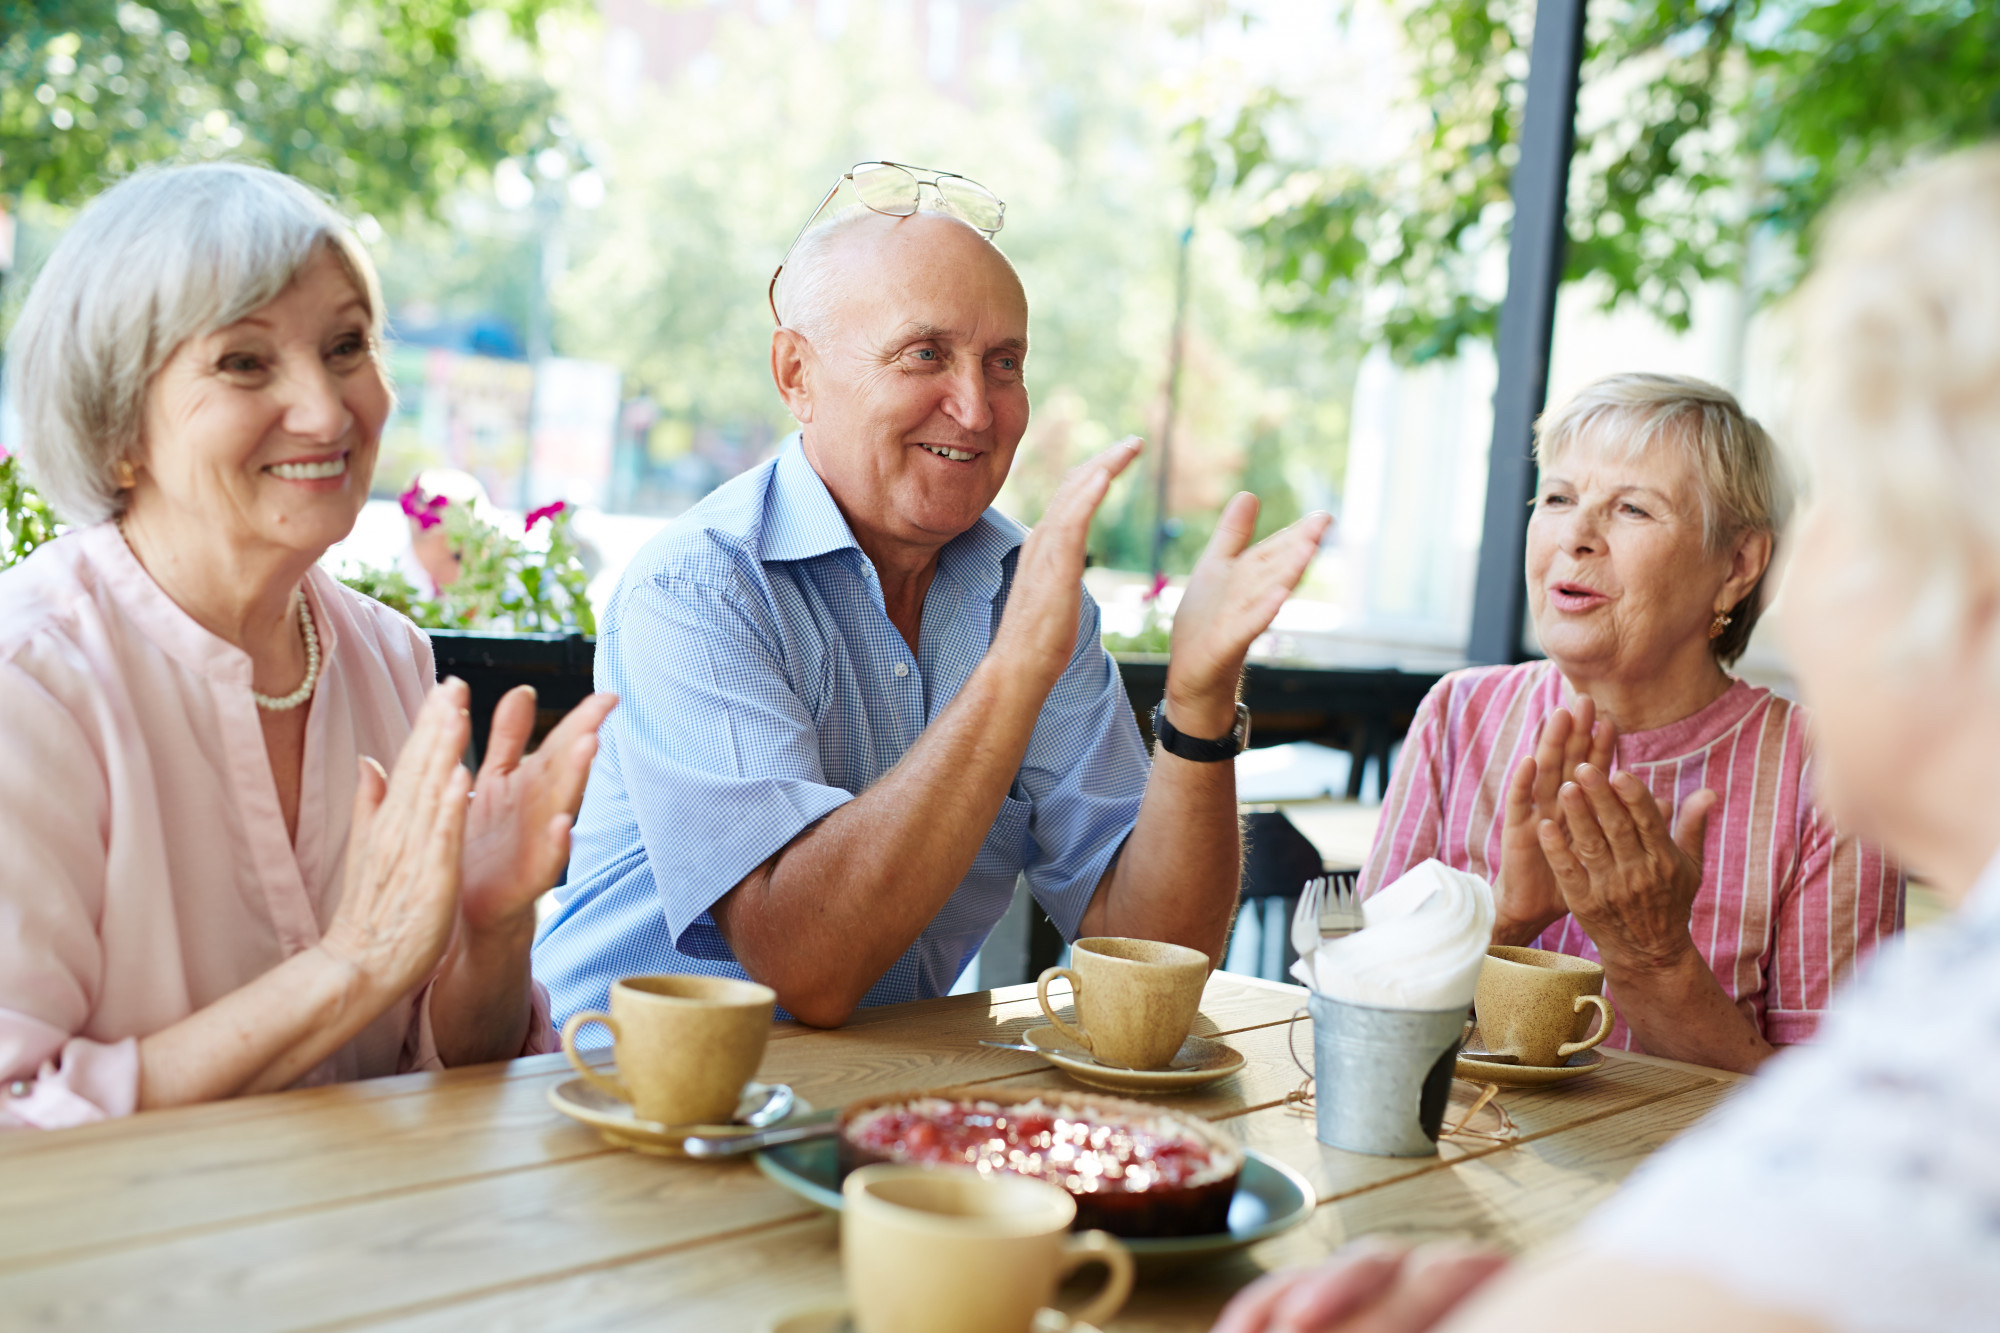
[534,434,1150,1041]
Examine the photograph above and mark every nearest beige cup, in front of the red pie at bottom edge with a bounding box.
[840,1167,1132,1333]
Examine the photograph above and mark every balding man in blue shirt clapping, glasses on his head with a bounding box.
[534,168,1330,1031]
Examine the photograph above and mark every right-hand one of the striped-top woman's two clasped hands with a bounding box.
[1538,765,1716,973]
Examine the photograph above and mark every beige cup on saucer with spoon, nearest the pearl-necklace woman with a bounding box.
[562,975,778,1125]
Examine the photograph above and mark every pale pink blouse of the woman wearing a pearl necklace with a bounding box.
[0,524,554,1129]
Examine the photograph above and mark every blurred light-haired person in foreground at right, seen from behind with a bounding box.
[1216,148,2000,1333]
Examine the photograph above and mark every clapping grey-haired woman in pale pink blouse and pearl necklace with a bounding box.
[0,164,612,1129]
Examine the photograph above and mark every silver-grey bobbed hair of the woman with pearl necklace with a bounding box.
[8,162,382,522]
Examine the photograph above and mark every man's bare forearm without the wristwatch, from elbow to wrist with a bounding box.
[714,656,1048,1027]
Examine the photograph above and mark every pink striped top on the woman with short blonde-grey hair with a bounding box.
[1360,662,1904,1051]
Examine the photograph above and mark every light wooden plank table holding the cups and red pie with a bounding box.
[0,973,1734,1333]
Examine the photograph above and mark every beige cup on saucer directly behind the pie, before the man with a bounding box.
[1036,937,1208,1069]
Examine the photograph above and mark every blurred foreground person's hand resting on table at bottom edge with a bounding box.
[1214,1239,1506,1333]
